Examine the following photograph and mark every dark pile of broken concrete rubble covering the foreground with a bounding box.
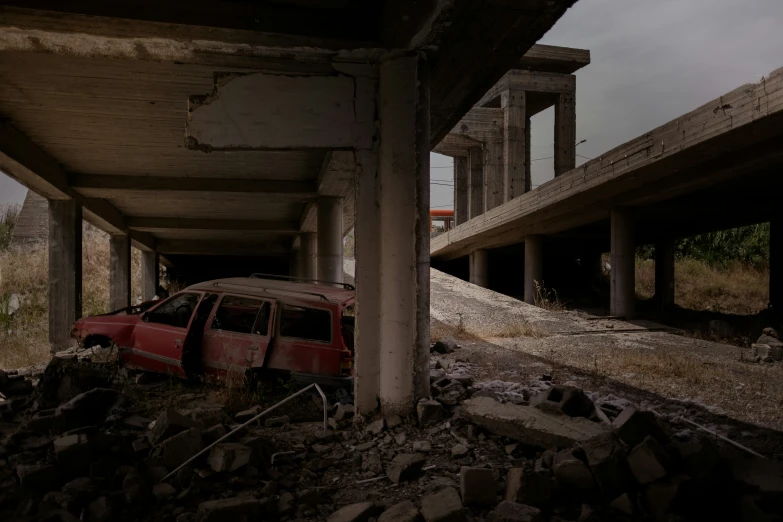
[0,345,783,522]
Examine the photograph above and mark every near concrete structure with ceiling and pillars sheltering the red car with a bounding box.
[0,0,575,413]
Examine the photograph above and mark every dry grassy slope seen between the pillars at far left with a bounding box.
[0,223,141,369]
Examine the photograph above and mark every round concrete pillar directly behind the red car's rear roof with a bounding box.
[318,196,343,283]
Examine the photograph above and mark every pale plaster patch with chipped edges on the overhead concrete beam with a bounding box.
[186,73,376,150]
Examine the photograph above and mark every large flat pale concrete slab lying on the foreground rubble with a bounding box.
[462,397,610,448]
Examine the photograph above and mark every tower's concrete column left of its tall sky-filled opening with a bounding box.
[500,88,530,202]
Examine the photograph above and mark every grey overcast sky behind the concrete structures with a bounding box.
[0,0,783,208]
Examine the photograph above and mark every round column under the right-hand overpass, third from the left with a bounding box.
[610,207,636,319]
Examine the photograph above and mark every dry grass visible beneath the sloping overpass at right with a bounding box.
[636,259,769,315]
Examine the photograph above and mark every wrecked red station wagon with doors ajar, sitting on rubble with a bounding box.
[71,274,355,385]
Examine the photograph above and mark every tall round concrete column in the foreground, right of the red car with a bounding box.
[378,55,430,415]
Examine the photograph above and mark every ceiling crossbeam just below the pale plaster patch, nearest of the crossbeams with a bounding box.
[69,174,318,197]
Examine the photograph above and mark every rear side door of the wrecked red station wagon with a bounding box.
[202,294,272,376]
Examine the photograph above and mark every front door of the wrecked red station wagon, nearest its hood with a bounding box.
[128,292,203,377]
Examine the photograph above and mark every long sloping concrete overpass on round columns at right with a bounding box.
[430,65,783,317]
